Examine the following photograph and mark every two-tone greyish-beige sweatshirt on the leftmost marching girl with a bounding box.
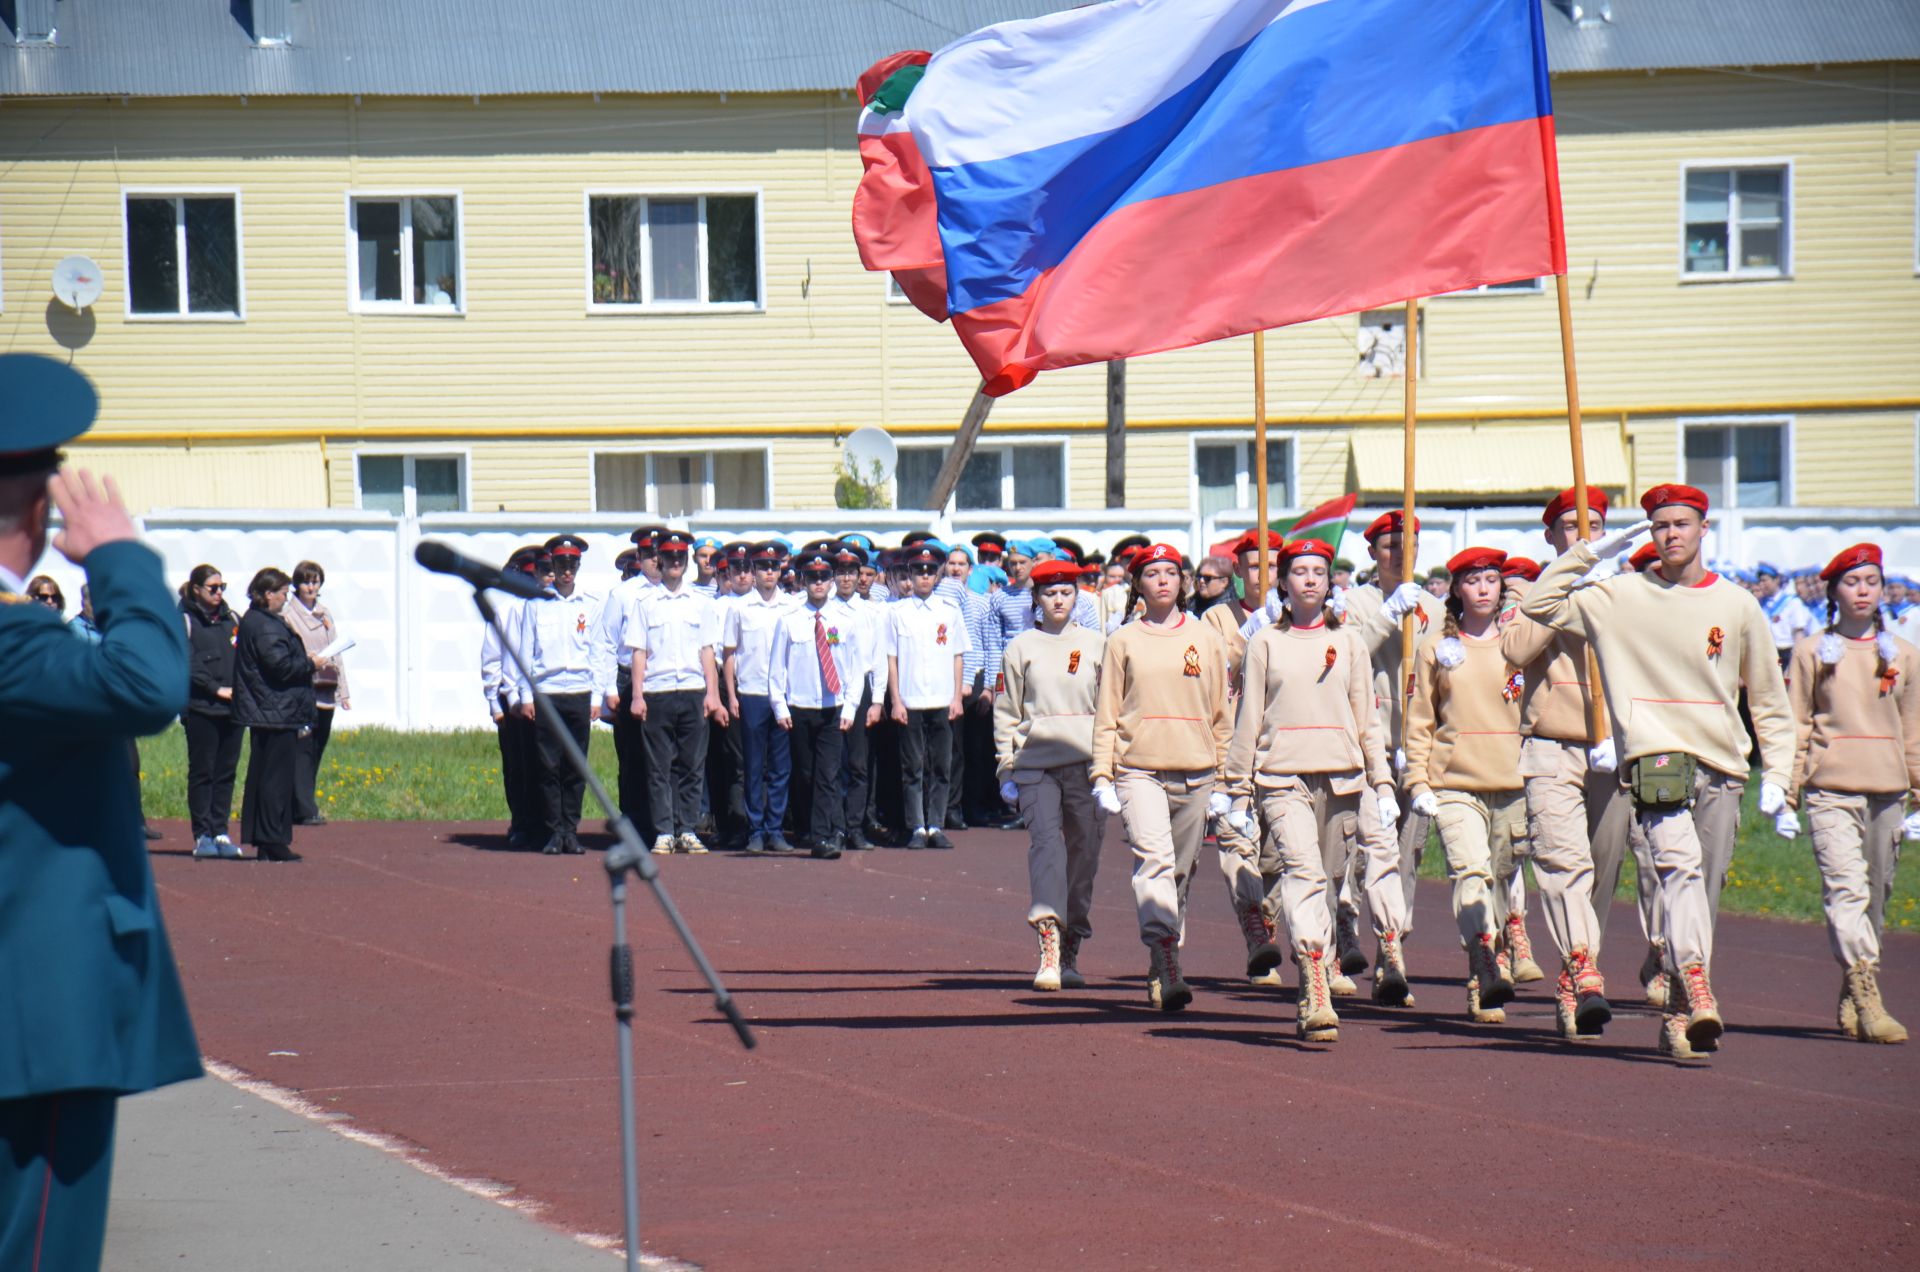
[993,623,1106,782]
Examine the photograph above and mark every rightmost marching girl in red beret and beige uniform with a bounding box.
[1776,544,1920,1043]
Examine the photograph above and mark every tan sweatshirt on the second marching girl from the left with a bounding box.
[1092,615,1233,782]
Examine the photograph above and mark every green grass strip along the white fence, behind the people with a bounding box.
[140,726,1920,932]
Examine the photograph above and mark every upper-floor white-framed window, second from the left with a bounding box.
[348,194,465,313]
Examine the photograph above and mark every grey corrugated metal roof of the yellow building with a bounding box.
[0,0,1920,96]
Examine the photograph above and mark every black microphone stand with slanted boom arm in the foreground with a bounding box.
[474,586,756,1272]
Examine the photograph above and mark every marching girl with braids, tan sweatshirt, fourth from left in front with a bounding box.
[1407,548,1526,1024]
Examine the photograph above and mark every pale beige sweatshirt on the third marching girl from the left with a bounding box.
[1225,624,1392,795]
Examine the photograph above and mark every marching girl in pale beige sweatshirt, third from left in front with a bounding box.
[1225,540,1411,1041]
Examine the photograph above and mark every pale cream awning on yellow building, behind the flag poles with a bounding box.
[1352,423,1630,501]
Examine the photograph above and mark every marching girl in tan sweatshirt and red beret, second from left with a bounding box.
[1091,544,1233,1011]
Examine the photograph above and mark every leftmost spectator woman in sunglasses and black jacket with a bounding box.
[180,565,246,859]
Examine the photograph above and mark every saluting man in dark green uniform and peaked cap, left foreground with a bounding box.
[0,354,200,1272]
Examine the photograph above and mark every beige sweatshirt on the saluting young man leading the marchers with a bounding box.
[1521,544,1793,788]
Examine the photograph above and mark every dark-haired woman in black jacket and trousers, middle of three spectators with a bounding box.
[232,567,319,861]
